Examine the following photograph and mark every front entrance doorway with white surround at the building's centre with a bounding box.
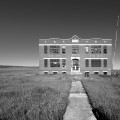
[71,57,80,73]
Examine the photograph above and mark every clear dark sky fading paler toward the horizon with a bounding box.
[0,0,120,69]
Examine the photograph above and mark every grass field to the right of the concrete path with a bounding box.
[82,75,120,120]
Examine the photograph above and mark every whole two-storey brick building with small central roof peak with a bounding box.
[39,35,113,75]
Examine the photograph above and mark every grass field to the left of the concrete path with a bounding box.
[0,66,71,120]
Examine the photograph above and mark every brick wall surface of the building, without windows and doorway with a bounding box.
[39,36,113,74]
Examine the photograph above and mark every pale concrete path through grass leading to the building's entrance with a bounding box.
[64,76,96,120]
